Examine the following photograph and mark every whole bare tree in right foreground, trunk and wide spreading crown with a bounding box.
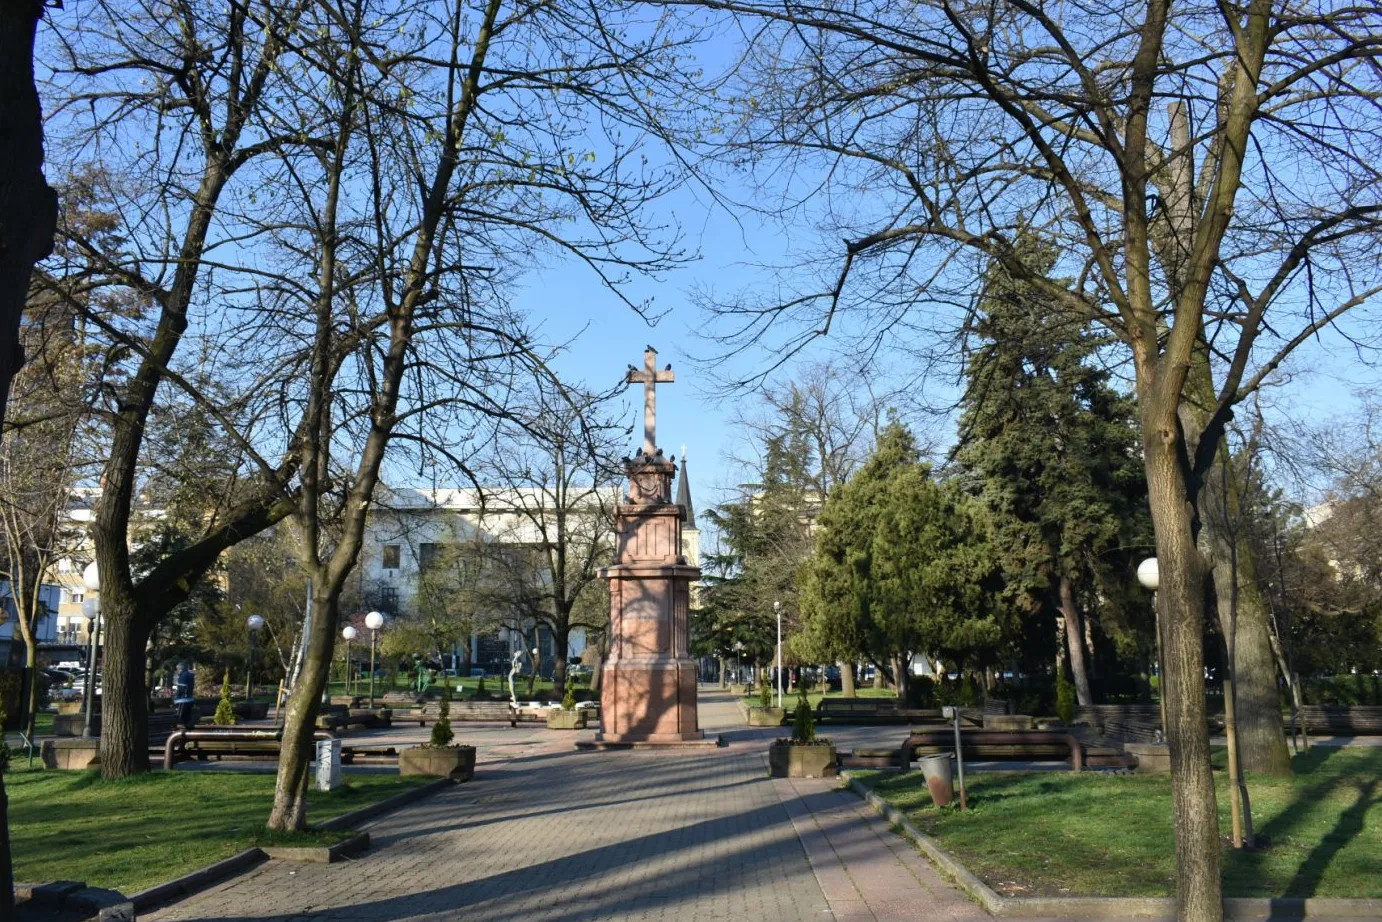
[688,0,1382,922]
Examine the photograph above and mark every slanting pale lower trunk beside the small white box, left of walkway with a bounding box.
[268,587,340,832]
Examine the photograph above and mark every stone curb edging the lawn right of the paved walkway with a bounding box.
[840,771,1382,922]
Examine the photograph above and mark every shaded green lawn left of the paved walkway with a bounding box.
[6,762,430,893]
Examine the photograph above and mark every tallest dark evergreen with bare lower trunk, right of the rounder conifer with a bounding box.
[954,239,1154,705]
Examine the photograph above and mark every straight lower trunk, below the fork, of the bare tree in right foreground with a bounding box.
[1142,428,1223,922]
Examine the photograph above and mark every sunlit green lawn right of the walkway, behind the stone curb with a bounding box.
[858,746,1382,897]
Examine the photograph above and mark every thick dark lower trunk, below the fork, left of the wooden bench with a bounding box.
[98,605,149,778]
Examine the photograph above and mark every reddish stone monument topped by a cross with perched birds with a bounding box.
[596,346,714,746]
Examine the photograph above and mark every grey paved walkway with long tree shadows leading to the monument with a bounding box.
[144,694,1006,922]
